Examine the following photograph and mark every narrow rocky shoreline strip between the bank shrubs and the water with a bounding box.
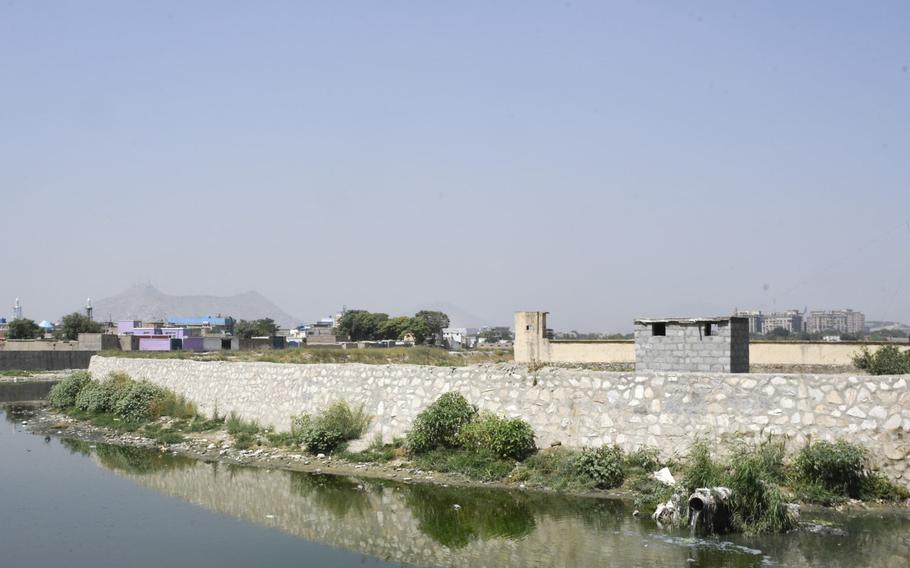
[10,401,910,519]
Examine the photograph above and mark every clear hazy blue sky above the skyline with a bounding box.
[0,0,910,330]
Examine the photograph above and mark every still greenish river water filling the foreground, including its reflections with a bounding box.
[0,406,910,568]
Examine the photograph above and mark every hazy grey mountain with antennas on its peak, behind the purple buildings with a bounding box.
[92,284,299,327]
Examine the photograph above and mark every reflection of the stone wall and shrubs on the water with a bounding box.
[71,444,910,567]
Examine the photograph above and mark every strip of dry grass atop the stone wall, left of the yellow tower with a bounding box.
[100,346,513,367]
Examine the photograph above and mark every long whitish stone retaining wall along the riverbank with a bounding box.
[90,356,910,486]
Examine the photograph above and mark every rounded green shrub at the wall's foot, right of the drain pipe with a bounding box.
[793,440,866,499]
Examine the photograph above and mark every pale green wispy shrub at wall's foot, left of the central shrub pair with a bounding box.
[291,400,370,454]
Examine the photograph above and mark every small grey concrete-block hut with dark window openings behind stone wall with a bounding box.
[635,316,749,373]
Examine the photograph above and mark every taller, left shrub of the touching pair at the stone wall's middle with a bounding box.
[407,392,477,454]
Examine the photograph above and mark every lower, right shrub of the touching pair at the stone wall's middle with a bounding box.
[457,414,537,461]
